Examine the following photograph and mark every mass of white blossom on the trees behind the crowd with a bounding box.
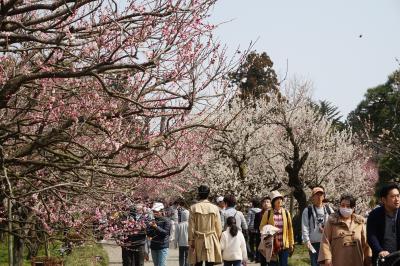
[196,84,377,212]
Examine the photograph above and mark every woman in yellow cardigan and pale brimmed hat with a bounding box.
[259,191,294,266]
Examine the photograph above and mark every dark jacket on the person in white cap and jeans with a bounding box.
[147,217,171,250]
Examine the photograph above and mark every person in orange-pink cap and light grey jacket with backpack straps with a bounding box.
[301,186,333,266]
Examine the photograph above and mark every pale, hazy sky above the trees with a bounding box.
[211,0,400,117]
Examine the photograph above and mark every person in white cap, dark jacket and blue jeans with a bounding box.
[147,202,171,266]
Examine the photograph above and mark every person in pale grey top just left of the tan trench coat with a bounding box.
[175,208,189,266]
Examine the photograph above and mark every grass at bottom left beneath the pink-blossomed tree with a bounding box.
[0,239,108,266]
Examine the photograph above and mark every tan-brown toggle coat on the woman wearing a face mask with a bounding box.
[318,213,372,266]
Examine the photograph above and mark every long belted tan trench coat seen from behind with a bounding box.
[189,200,222,263]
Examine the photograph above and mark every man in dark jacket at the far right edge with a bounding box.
[367,184,400,262]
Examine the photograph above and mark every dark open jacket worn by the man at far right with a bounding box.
[367,207,400,262]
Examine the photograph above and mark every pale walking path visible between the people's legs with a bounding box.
[101,240,257,266]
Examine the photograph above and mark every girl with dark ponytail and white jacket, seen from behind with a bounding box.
[221,216,247,266]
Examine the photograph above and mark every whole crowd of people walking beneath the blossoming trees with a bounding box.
[122,184,400,266]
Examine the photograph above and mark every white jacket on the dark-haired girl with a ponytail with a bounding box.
[221,227,247,261]
